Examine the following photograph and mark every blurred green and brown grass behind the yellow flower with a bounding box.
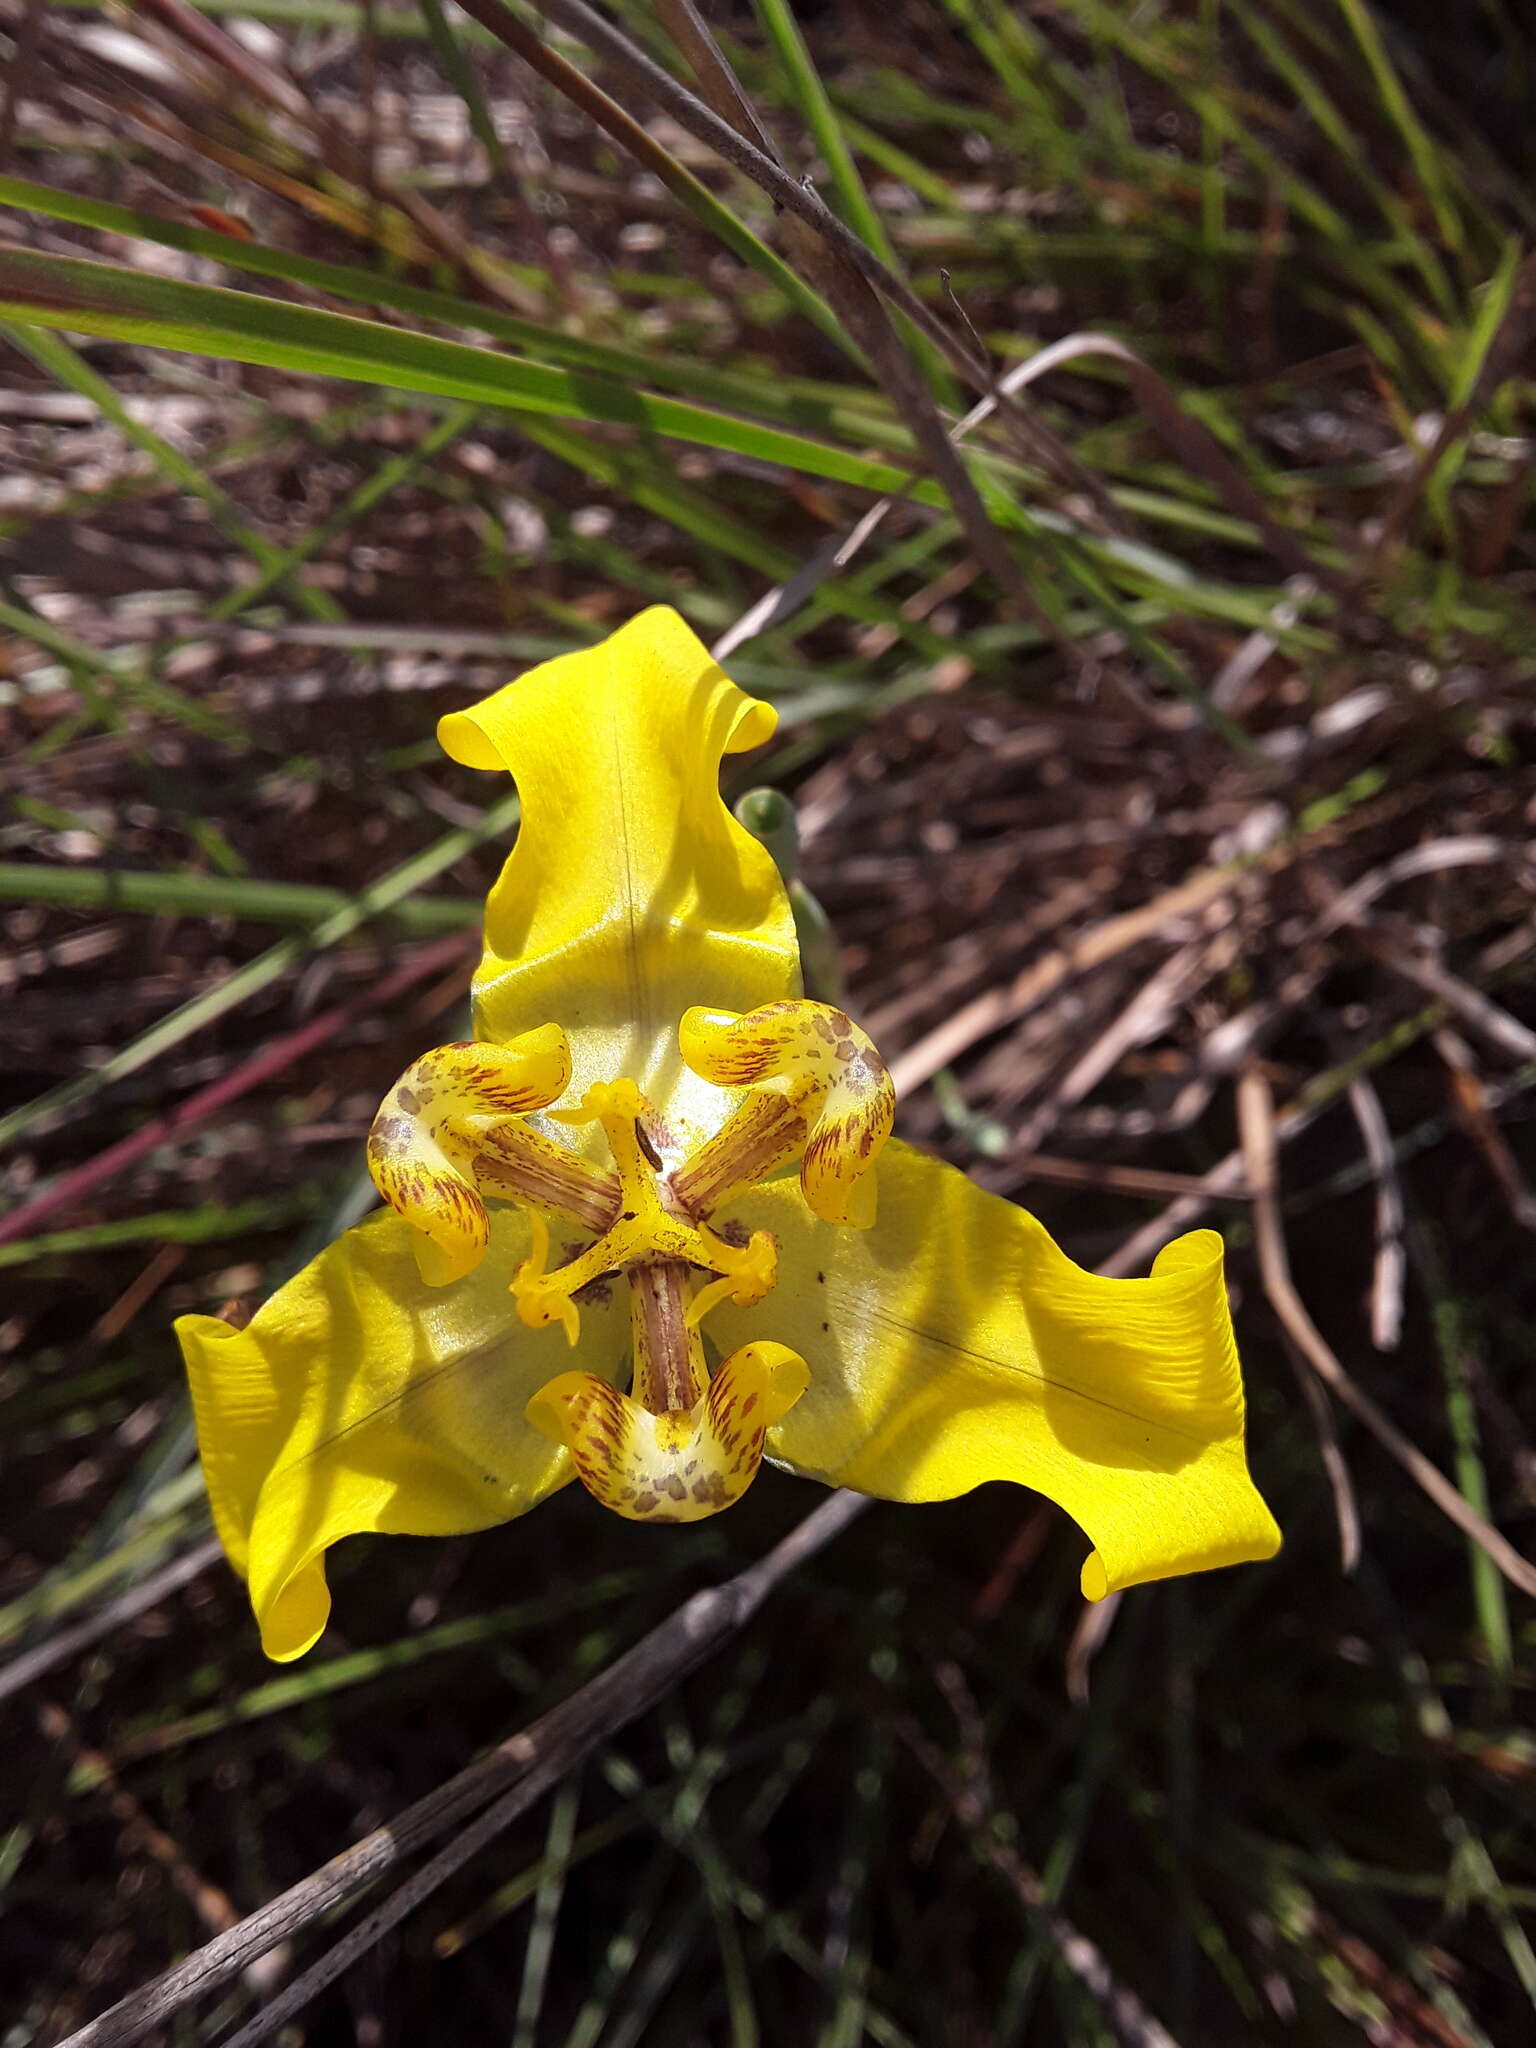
[0,0,1536,2048]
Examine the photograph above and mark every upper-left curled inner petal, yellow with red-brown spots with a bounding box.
[369,1024,618,1286]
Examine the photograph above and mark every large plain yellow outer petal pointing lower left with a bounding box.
[176,1212,629,1661]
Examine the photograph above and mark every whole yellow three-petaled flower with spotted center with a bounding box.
[176,608,1280,1659]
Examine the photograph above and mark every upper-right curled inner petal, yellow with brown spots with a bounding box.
[676,1001,895,1229]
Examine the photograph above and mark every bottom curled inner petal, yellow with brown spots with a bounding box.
[526,1343,811,1522]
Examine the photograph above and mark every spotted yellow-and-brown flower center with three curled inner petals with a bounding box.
[369,1001,893,1522]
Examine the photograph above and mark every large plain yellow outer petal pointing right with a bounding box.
[711,1145,1280,1599]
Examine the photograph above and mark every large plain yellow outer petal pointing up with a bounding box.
[438,606,799,1149]
